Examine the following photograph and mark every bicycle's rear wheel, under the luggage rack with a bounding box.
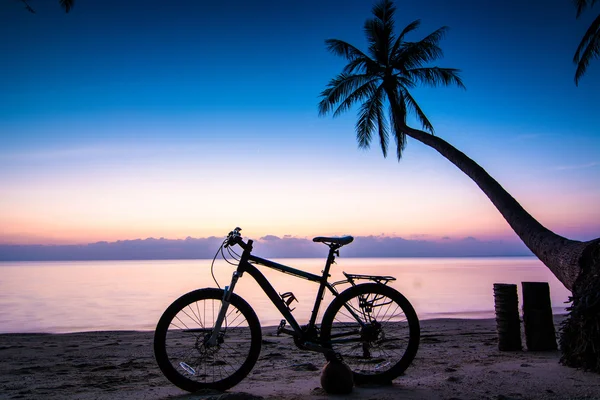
[321,283,420,384]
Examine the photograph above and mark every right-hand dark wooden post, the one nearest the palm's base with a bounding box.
[521,282,557,351]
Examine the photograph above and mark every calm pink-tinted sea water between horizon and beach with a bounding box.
[0,257,569,333]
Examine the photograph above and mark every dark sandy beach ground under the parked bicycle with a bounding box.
[0,317,600,400]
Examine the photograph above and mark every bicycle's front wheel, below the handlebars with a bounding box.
[154,289,262,392]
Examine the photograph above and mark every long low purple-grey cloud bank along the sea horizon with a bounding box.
[0,235,531,261]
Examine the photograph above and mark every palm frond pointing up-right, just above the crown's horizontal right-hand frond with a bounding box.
[392,26,448,68]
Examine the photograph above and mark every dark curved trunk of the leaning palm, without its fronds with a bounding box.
[400,125,600,373]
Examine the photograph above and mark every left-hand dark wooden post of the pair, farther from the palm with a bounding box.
[494,283,522,351]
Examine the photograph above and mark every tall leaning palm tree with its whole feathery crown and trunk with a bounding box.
[319,0,600,372]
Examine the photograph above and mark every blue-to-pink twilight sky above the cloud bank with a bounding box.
[0,0,600,252]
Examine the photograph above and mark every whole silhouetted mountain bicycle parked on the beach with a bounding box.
[154,228,420,392]
